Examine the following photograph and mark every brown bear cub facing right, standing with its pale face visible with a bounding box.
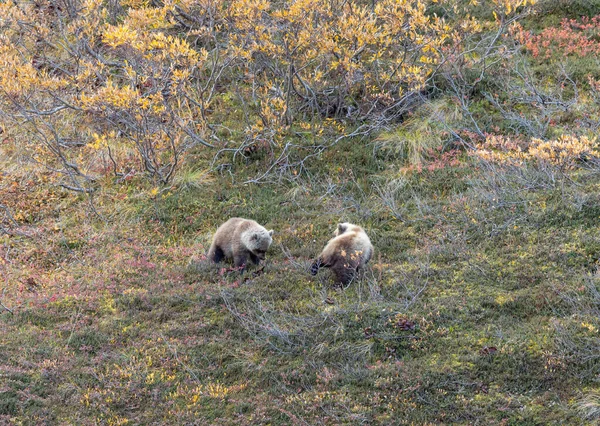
[208,217,273,270]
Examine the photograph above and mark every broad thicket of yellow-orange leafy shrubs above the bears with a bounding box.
[0,0,532,183]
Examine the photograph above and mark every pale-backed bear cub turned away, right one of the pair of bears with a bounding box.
[311,222,373,286]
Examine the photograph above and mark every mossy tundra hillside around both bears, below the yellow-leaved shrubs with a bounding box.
[0,2,600,425]
